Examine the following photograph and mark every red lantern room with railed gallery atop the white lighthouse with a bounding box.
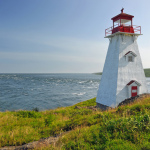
[105,8,141,36]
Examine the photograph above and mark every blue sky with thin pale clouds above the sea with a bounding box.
[0,0,150,73]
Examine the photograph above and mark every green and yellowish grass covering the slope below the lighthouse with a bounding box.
[0,97,150,150]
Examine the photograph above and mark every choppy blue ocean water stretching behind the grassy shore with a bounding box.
[0,74,150,111]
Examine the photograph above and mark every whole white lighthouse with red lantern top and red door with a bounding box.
[96,9,148,109]
